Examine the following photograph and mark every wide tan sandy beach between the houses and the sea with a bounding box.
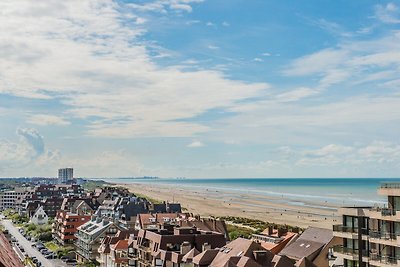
[119,184,339,229]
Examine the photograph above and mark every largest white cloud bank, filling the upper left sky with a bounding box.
[0,0,268,140]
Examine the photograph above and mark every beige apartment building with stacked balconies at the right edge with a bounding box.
[333,183,400,267]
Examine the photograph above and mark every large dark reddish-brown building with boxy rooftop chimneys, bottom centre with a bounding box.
[129,225,226,267]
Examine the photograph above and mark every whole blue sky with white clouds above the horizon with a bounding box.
[0,0,400,178]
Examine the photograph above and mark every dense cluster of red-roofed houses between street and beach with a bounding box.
[1,181,340,267]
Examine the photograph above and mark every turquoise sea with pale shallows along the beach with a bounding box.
[102,178,400,210]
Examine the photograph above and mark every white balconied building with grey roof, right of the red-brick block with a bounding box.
[75,215,127,262]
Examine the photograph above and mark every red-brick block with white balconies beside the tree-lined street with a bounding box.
[52,199,94,245]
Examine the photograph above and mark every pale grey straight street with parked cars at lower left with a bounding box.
[1,220,67,267]
